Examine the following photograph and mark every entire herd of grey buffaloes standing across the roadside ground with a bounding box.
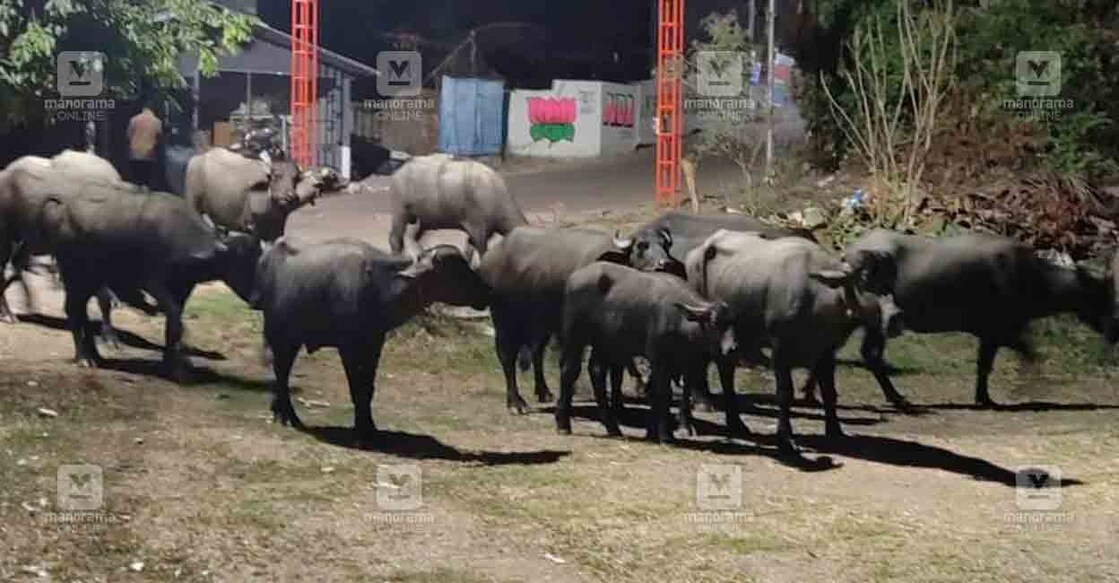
[0,148,1119,451]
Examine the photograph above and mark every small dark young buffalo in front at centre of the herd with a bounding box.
[555,262,741,442]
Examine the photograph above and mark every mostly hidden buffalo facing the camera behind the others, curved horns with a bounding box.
[633,210,816,273]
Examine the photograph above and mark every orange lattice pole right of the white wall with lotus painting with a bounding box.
[655,0,685,207]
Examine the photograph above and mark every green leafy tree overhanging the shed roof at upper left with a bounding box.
[0,0,256,131]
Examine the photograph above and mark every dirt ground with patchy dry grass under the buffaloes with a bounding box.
[0,157,1119,583]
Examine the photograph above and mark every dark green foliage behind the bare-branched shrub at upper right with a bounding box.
[798,0,1119,184]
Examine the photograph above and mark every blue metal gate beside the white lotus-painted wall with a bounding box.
[439,77,505,156]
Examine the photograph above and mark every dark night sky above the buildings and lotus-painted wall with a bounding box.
[250,0,802,91]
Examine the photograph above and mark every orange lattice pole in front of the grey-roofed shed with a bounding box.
[291,0,319,168]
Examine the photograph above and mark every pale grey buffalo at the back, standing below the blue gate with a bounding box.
[388,154,528,255]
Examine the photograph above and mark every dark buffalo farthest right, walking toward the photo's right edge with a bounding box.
[810,229,1116,406]
